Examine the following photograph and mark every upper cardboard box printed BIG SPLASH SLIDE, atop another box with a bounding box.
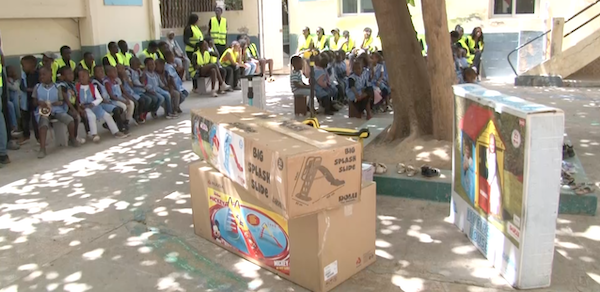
[192,106,362,219]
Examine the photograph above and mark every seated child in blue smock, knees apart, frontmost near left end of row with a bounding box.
[32,67,79,158]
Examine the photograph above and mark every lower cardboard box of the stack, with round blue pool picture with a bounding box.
[190,162,376,292]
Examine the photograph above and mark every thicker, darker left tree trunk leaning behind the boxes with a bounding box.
[373,0,428,140]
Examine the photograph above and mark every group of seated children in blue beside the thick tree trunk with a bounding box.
[290,50,391,119]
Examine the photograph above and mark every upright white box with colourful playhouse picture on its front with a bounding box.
[450,84,564,289]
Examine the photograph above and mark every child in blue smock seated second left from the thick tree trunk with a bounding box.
[346,62,373,120]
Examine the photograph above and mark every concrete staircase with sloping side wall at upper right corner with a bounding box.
[507,0,600,87]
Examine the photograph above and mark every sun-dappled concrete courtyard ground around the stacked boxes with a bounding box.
[0,78,600,292]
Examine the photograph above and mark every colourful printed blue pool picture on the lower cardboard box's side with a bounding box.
[208,188,289,275]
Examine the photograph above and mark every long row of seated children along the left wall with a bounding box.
[6,42,189,158]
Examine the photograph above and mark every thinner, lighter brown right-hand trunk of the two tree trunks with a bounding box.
[421,0,456,141]
